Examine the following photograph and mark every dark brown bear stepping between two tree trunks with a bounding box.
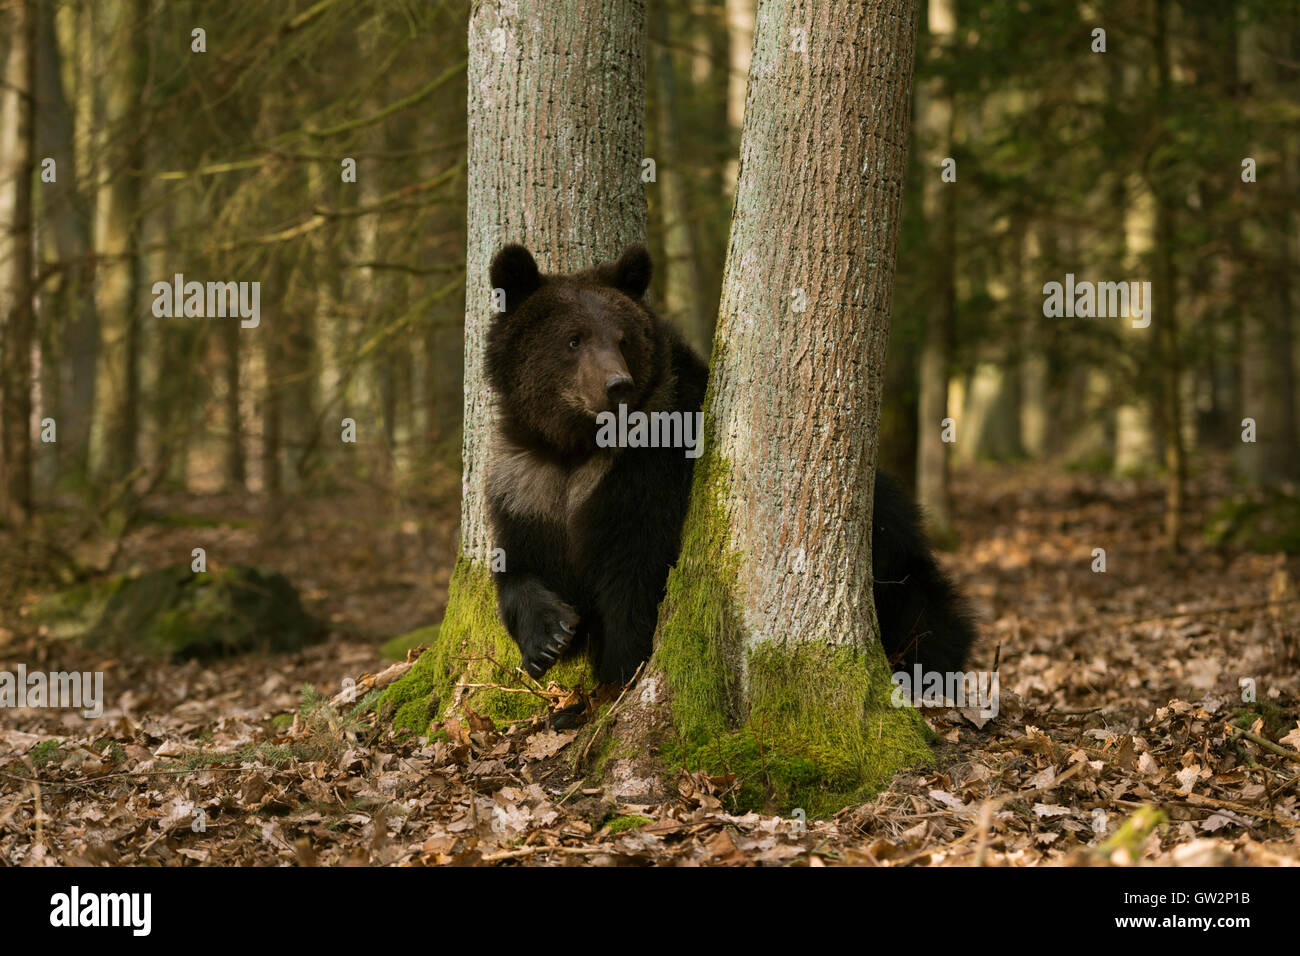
[486,245,975,682]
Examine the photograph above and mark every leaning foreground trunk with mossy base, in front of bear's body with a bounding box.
[602,0,927,813]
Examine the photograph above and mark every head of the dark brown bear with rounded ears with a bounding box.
[486,245,658,451]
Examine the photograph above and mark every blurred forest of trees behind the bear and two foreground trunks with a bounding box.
[0,0,1300,632]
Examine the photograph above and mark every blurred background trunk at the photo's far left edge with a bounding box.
[0,0,36,524]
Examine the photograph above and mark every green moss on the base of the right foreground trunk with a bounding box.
[653,436,932,816]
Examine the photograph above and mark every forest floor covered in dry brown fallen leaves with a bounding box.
[0,467,1300,866]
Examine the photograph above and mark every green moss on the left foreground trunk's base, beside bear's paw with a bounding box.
[378,555,592,734]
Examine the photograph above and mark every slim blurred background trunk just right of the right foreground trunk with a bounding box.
[917,0,957,541]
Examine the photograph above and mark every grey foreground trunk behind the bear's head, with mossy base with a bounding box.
[386,0,646,731]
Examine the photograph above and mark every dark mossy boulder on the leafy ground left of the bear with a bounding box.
[33,564,325,658]
